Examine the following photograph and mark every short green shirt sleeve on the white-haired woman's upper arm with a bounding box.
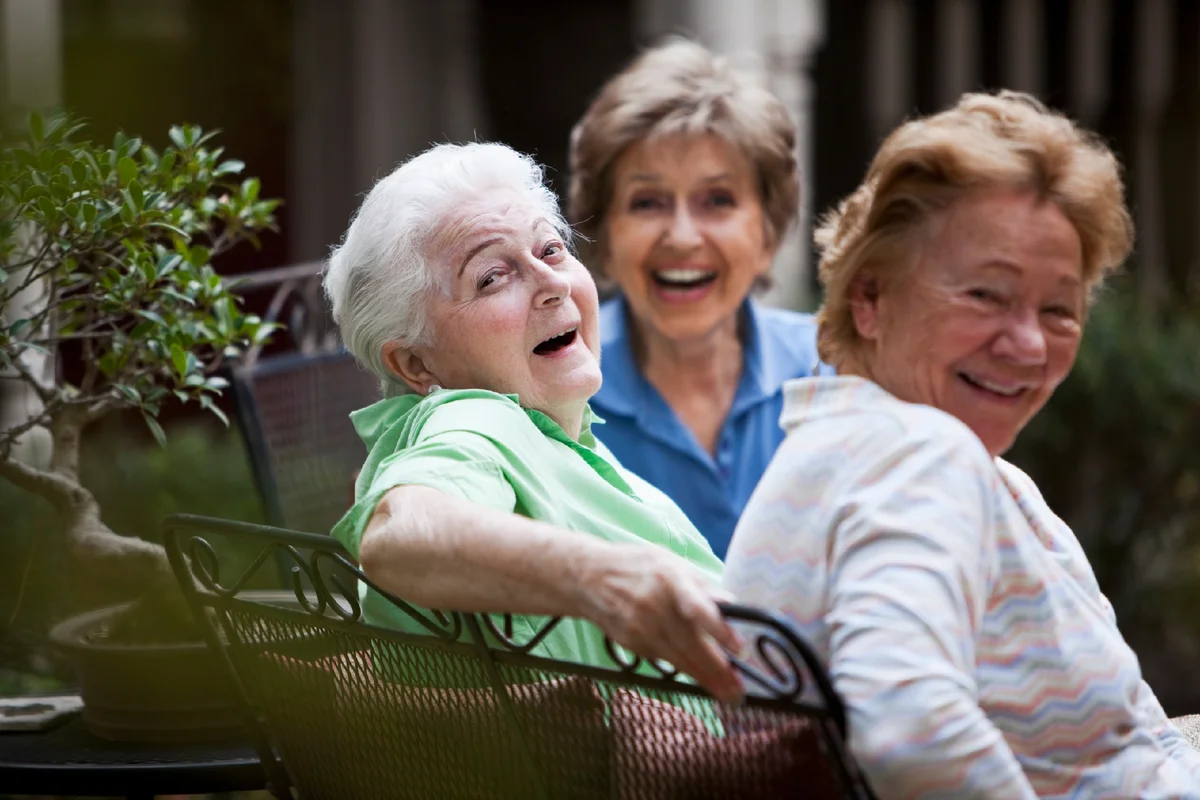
[334,431,517,558]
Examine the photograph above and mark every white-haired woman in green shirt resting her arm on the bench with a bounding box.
[325,144,740,699]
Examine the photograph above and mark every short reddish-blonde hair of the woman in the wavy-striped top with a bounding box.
[814,91,1133,367]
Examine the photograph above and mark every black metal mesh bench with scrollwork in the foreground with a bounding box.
[164,516,871,800]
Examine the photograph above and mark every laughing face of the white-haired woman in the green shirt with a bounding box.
[391,196,600,424]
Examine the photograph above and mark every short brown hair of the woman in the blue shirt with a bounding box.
[568,37,800,267]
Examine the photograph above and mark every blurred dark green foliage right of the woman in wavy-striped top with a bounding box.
[1008,283,1200,714]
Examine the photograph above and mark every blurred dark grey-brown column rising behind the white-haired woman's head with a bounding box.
[288,0,486,261]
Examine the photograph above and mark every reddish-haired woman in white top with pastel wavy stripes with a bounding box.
[726,92,1200,800]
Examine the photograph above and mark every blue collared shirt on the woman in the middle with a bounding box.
[592,296,833,559]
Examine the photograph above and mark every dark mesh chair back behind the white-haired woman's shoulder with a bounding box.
[230,349,379,533]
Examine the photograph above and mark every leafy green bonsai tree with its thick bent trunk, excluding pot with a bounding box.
[0,114,278,638]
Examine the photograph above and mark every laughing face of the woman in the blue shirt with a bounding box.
[605,134,774,342]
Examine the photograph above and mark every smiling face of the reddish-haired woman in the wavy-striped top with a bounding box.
[852,190,1086,456]
